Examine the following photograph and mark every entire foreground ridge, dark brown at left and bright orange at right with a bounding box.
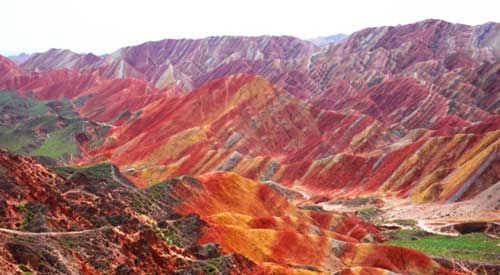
[0,151,456,274]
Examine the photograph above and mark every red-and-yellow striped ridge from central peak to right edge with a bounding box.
[88,75,500,205]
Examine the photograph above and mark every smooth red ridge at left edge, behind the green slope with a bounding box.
[0,59,182,127]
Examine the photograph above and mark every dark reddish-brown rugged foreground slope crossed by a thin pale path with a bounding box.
[0,151,262,274]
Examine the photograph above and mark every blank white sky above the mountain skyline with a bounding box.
[0,0,500,55]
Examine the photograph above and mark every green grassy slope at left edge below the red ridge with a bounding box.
[0,91,106,159]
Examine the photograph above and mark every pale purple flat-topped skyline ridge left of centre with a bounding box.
[99,36,317,90]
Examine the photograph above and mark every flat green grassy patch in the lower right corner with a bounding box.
[387,230,500,264]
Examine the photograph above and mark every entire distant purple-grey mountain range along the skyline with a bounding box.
[8,20,499,100]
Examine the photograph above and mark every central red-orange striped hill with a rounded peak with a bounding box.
[92,75,391,182]
